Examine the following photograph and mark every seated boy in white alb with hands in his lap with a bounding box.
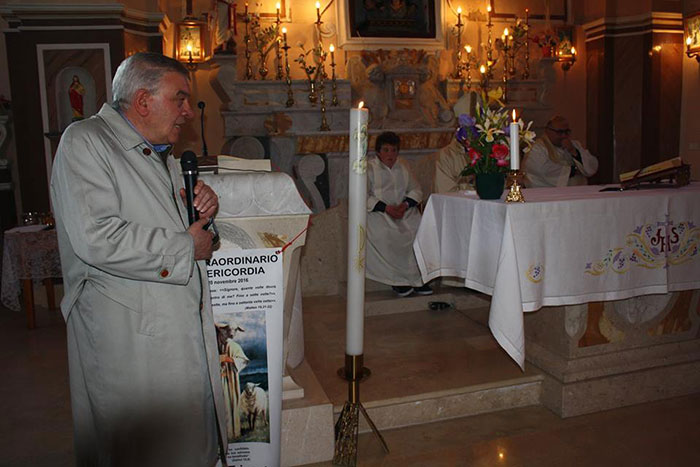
[365,131,433,297]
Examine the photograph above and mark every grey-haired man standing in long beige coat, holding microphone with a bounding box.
[51,53,226,467]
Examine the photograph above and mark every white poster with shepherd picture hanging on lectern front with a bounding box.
[207,248,284,467]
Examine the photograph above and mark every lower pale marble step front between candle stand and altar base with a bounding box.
[333,374,544,436]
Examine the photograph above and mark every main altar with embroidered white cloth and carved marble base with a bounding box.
[414,183,700,416]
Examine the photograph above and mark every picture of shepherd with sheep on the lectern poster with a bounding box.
[216,311,270,443]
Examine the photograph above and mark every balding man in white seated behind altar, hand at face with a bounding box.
[523,116,598,188]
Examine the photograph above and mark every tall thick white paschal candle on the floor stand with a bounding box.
[345,102,369,355]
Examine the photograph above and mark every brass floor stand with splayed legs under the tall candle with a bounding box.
[333,354,389,466]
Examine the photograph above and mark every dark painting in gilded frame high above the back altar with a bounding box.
[336,0,444,50]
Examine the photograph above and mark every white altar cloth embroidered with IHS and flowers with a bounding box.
[413,183,700,368]
